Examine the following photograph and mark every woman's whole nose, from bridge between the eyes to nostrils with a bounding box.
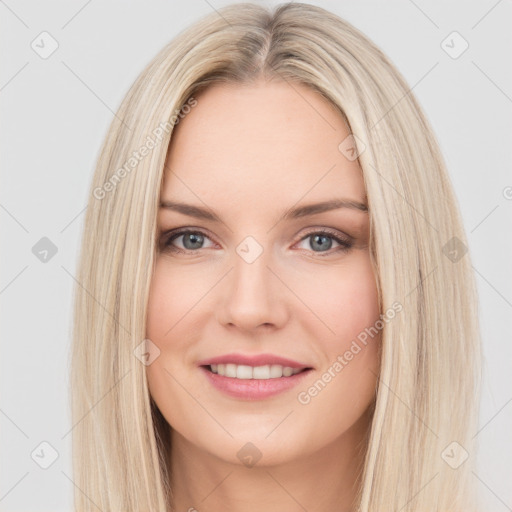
[217,236,286,329]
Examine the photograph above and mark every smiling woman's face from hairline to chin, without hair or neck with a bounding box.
[147,83,380,465]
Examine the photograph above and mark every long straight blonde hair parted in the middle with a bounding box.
[71,3,481,512]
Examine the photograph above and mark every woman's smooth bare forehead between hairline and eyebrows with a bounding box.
[162,82,364,208]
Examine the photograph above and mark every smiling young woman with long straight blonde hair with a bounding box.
[72,3,480,512]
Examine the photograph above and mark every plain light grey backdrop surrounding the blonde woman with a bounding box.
[0,0,512,512]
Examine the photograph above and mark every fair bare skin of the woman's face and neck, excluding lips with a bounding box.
[147,81,380,512]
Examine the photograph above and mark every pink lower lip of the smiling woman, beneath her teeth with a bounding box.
[200,366,311,400]
